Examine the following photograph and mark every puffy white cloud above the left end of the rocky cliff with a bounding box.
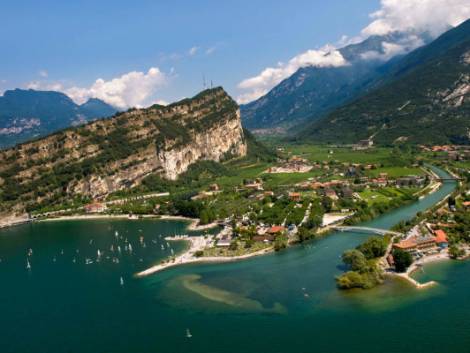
[64,67,167,109]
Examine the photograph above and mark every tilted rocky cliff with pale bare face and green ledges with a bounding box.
[0,88,247,210]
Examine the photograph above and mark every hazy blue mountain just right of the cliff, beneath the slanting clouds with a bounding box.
[241,32,428,129]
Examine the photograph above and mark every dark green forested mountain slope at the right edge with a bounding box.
[299,20,470,144]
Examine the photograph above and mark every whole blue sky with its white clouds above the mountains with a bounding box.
[0,0,470,109]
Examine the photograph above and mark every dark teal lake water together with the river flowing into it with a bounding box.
[0,166,470,353]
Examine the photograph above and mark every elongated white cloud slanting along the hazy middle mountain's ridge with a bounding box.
[237,45,348,103]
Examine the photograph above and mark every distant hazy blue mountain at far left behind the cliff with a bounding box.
[0,89,116,148]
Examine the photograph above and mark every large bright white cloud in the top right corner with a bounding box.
[362,0,470,37]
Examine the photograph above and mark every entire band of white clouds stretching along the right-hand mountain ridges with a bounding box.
[237,0,470,103]
